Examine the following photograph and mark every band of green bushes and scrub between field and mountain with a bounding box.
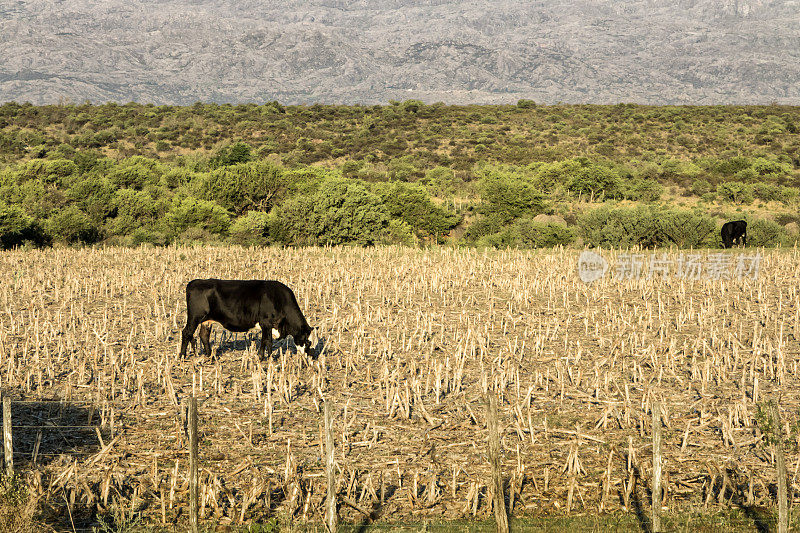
[0,101,800,248]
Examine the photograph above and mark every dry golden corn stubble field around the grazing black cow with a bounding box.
[0,247,800,527]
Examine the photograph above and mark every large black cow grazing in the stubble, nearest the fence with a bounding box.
[180,279,313,359]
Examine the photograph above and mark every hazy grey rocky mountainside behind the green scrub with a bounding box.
[0,0,800,104]
